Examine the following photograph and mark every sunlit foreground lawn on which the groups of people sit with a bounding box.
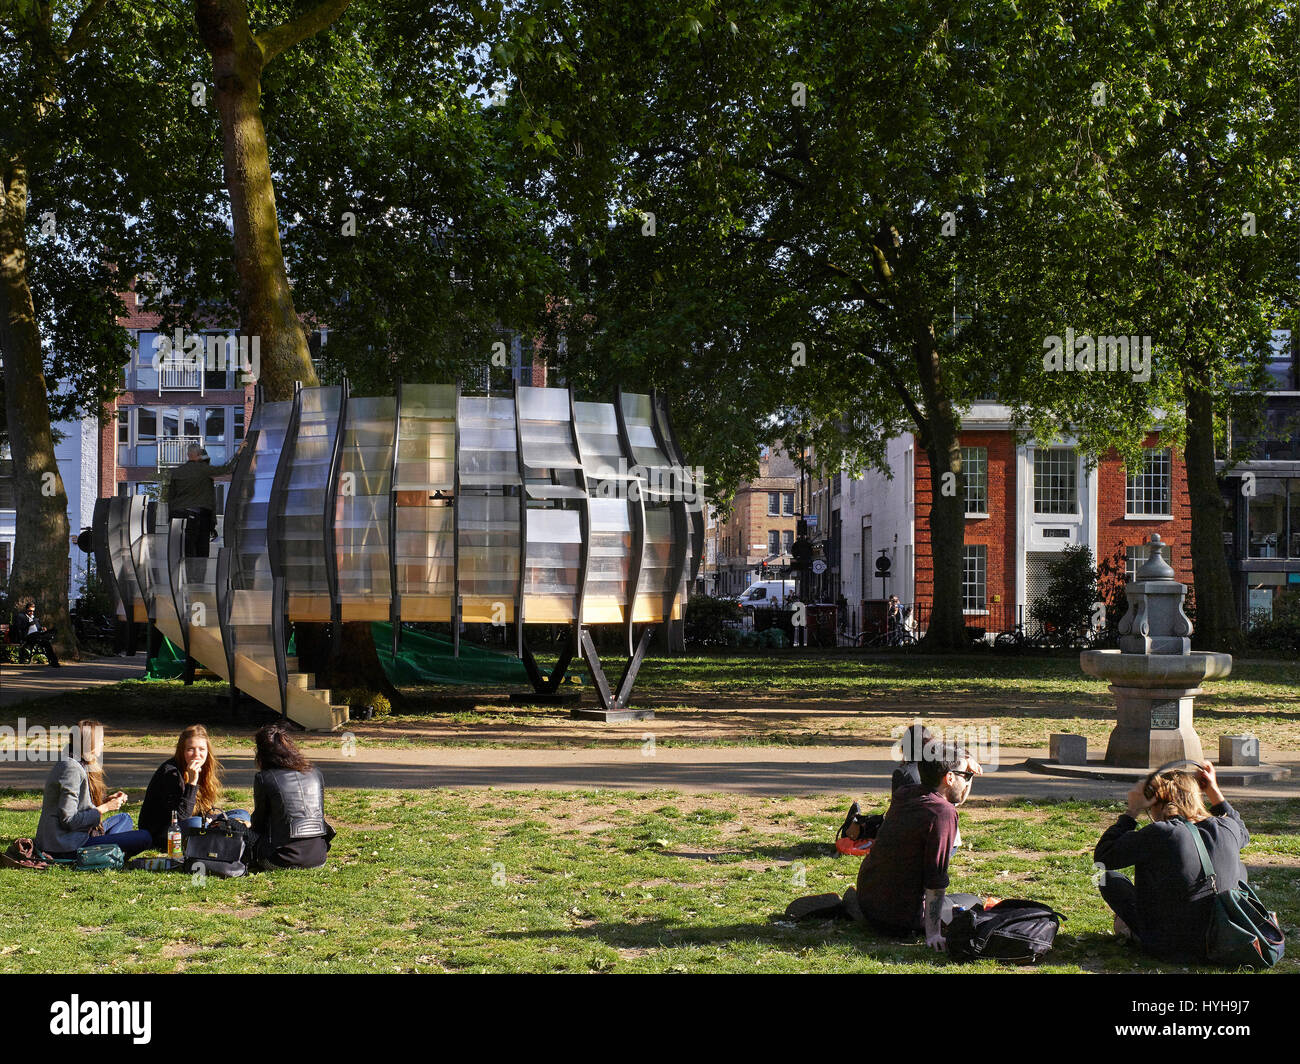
[0,791,1300,973]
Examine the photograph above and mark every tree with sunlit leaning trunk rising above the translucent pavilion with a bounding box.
[182,0,564,692]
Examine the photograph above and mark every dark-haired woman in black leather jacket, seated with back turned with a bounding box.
[248,725,334,869]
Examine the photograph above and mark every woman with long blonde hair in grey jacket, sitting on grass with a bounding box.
[35,721,153,857]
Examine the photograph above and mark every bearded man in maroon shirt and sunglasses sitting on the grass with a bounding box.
[858,743,980,951]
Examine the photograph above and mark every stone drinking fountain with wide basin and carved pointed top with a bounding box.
[1079,536,1232,769]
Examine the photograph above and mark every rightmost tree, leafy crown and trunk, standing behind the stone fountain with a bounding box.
[1055,0,1300,652]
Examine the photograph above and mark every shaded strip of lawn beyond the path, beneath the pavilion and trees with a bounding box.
[0,650,1300,758]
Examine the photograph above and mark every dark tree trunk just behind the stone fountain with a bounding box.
[1184,386,1243,654]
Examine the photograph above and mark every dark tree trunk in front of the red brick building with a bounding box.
[914,324,967,650]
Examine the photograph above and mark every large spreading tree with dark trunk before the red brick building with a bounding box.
[498,0,1138,648]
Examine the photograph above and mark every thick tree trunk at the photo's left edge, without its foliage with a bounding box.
[0,156,77,659]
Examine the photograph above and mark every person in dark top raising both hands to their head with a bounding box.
[1093,761,1251,963]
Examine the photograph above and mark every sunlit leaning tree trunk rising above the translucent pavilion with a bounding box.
[194,0,317,402]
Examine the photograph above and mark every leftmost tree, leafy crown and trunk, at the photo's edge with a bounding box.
[0,0,200,657]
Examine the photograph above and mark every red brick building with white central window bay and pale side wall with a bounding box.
[840,402,1192,631]
